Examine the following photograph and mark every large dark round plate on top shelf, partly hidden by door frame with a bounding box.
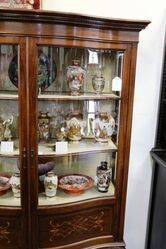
[8,52,57,91]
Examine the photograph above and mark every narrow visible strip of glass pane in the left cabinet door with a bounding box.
[0,45,20,206]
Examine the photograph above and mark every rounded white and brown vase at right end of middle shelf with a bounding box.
[90,112,115,142]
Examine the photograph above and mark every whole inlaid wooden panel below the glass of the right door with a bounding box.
[39,208,113,248]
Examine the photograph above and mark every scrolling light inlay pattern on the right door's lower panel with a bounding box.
[49,211,104,242]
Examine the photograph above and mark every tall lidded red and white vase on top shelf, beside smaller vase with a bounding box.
[67,60,85,95]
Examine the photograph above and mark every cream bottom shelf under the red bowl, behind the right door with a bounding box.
[38,183,115,206]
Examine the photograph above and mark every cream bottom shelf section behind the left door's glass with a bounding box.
[0,191,21,207]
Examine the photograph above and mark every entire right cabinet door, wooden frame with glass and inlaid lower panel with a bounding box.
[29,39,130,248]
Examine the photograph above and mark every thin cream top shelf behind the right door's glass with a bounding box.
[38,93,120,101]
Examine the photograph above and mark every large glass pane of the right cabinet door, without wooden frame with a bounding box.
[36,46,124,206]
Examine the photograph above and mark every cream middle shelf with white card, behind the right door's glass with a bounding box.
[38,139,117,157]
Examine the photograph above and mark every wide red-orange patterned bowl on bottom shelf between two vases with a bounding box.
[58,174,94,195]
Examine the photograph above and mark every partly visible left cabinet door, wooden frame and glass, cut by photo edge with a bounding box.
[0,38,28,248]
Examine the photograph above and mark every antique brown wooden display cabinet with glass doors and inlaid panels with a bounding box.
[0,9,149,249]
